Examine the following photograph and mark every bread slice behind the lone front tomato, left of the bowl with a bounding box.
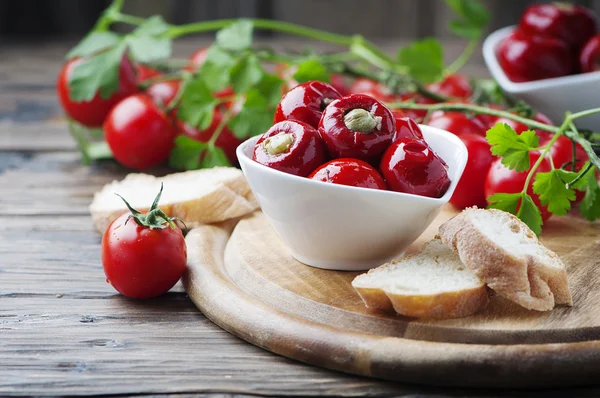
[90,167,258,233]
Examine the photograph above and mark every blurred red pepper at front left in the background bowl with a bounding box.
[497,30,573,82]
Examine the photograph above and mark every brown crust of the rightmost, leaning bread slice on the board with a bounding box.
[440,208,573,311]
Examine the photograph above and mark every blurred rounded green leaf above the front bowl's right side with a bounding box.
[398,38,444,83]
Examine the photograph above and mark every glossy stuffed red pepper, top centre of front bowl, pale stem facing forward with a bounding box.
[319,94,396,163]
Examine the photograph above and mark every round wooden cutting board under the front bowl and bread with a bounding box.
[184,210,600,388]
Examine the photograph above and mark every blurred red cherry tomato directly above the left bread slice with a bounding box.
[104,94,175,169]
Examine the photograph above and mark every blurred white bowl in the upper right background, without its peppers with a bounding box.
[483,26,600,130]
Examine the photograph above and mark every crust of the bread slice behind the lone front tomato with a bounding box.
[90,168,258,233]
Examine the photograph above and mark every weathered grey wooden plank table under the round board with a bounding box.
[0,42,600,397]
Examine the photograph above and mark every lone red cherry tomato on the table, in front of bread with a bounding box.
[102,197,187,299]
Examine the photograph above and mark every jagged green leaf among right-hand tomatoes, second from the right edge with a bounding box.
[533,169,577,216]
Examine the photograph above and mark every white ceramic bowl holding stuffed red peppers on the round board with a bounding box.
[237,126,468,271]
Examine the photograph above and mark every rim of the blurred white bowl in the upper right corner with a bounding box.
[483,25,600,93]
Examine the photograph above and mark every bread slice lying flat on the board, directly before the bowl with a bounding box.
[352,239,489,319]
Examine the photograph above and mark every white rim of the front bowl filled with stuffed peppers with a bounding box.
[236,124,469,205]
